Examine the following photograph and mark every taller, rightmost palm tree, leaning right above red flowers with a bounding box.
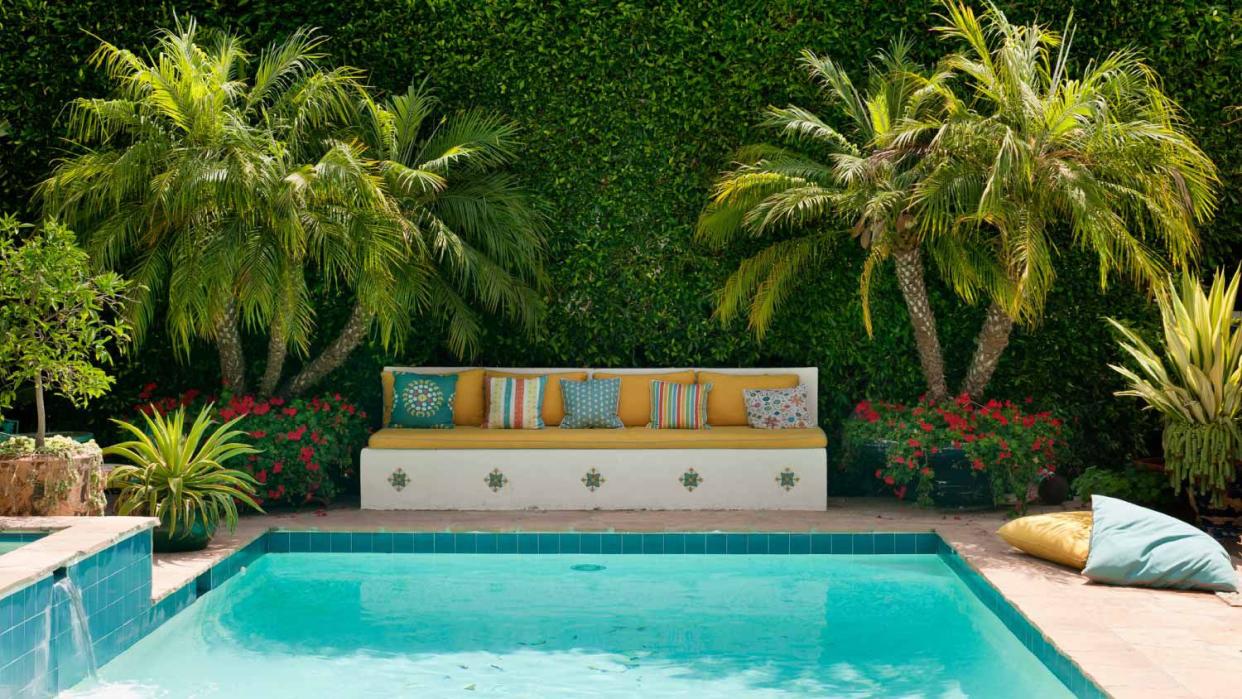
[919,0,1218,396]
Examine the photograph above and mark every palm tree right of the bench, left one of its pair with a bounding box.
[697,38,953,401]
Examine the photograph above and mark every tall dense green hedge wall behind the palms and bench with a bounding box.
[0,0,1242,491]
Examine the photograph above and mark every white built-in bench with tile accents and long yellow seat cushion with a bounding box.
[360,368,827,510]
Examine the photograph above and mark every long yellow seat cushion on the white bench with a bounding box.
[369,427,828,449]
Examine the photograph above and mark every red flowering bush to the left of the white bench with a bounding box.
[134,384,370,505]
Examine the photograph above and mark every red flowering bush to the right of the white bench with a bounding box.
[845,396,1066,510]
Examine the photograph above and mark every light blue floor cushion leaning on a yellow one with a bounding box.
[1083,495,1238,592]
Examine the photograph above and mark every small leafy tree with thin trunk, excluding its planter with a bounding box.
[0,216,129,449]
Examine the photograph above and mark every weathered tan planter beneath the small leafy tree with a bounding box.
[0,443,106,516]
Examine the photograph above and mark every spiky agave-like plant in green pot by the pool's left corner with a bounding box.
[103,405,262,552]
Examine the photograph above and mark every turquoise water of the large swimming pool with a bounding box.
[72,554,1071,698]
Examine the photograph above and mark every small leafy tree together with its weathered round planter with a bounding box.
[0,216,129,515]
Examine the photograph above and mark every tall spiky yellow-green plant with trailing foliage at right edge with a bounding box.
[1108,268,1242,507]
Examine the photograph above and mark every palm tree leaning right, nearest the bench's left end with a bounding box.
[288,86,548,394]
